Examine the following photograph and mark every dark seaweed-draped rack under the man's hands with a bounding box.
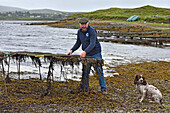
[0,52,104,97]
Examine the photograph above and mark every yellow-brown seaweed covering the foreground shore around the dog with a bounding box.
[0,61,170,113]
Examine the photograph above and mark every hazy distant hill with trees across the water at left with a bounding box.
[0,6,80,20]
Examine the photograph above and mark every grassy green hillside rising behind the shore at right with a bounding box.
[69,6,170,24]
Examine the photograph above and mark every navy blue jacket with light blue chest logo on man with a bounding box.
[71,26,101,56]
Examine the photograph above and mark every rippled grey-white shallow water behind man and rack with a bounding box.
[0,21,170,80]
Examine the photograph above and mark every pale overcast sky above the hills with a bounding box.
[0,0,170,12]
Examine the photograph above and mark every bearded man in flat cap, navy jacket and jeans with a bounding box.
[67,18,107,94]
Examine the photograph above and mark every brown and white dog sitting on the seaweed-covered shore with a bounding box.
[134,75,162,103]
